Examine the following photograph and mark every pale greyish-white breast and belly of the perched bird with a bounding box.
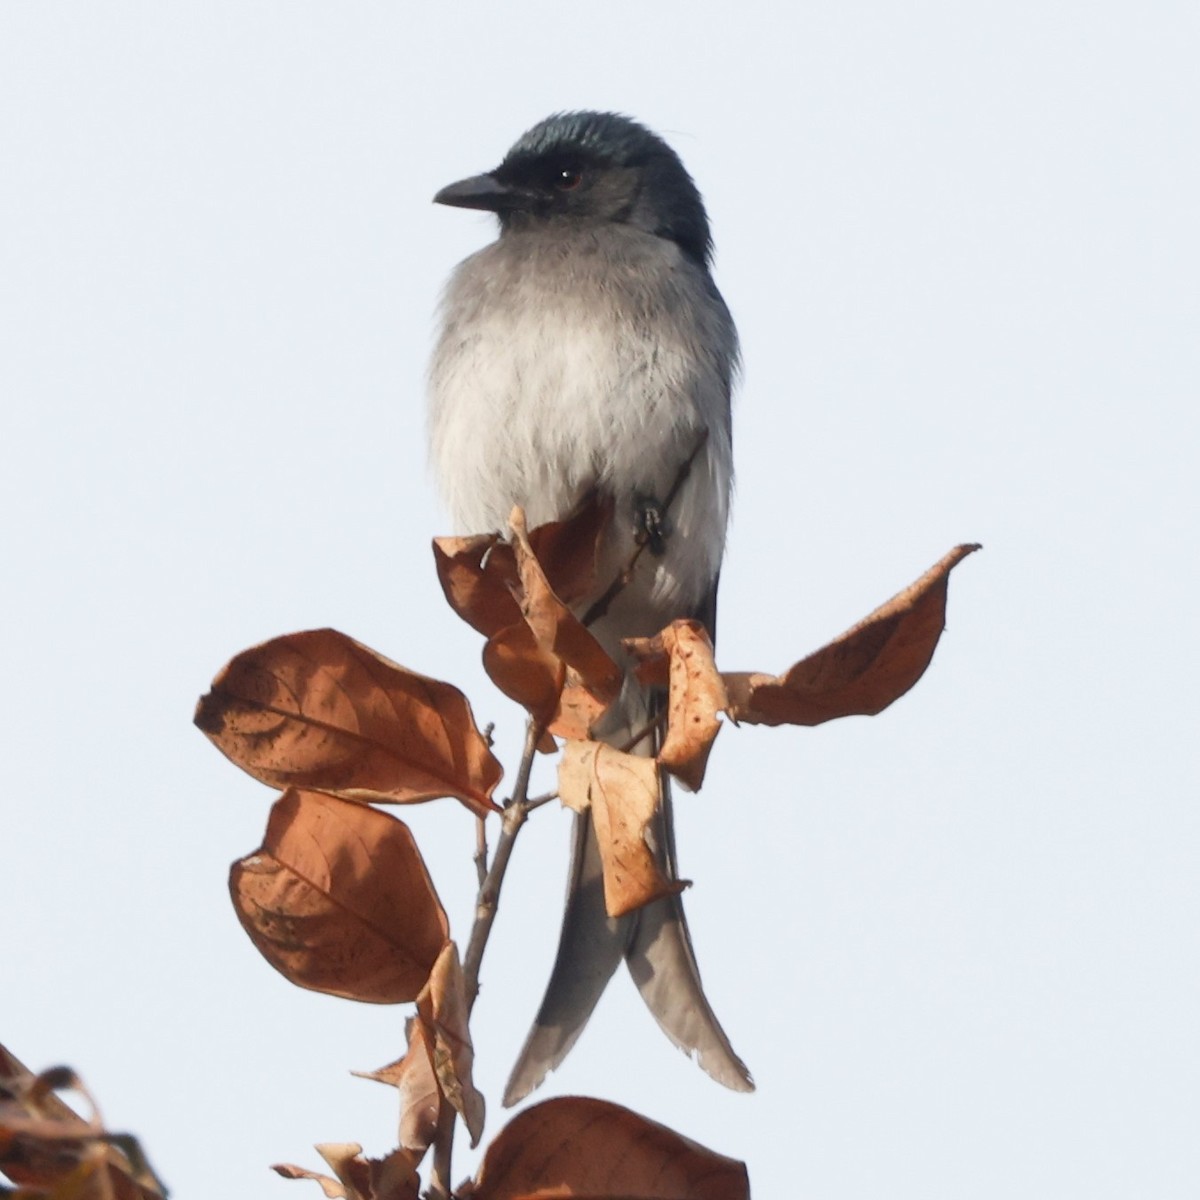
[430,227,737,635]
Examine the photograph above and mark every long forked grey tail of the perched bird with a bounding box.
[504,695,754,1106]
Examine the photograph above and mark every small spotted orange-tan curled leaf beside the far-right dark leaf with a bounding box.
[625,620,728,792]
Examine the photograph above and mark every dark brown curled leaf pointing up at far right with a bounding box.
[724,545,979,725]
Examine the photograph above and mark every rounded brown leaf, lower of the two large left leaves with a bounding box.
[229,788,449,1004]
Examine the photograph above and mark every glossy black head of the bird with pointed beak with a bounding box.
[433,113,713,266]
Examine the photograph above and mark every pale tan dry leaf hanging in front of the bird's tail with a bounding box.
[558,742,686,917]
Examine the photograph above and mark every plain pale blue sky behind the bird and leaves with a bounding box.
[0,0,1200,1200]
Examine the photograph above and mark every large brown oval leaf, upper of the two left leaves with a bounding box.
[196,629,502,814]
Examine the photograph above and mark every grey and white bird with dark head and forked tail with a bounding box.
[428,112,754,1106]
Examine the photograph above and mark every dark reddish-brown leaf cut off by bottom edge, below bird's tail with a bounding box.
[472,1096,750,1200]
